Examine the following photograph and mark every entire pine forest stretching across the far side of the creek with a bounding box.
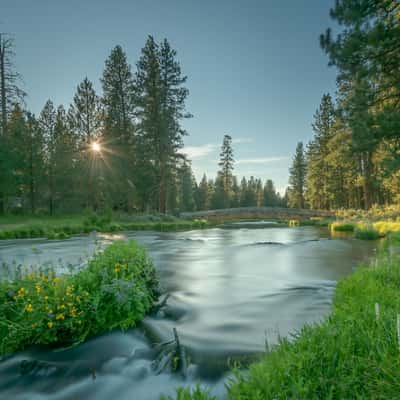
[0,1,400,215]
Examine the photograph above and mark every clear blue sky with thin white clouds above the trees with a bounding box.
[0,0,336,192]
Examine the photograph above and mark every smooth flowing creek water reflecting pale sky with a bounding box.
[0,224,376,400]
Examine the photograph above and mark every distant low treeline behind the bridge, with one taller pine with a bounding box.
[177,135,287,211]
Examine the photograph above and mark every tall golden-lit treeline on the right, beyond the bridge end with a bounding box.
[289,0,400,209]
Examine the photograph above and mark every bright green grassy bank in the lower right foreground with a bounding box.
[166,235,400,400]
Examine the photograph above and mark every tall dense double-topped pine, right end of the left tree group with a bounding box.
[135,36,190,213]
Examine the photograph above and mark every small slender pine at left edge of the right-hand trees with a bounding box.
[288,142,306,208]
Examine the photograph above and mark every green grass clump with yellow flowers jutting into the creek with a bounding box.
[0,241,157,354]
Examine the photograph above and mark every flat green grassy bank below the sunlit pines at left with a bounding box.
[0,214,215,239]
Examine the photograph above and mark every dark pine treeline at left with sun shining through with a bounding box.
[0,36,191,214]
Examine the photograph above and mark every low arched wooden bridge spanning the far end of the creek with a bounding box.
[180,207,335,221]
